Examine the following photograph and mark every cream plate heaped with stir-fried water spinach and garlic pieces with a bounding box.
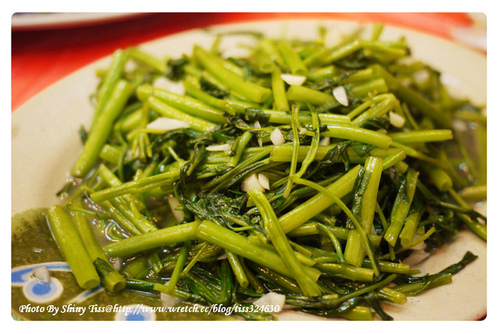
[12,21,487,320]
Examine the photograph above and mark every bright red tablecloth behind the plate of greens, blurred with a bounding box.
[11,12,471,111]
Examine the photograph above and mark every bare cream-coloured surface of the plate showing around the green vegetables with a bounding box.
[12,20,486,320]
